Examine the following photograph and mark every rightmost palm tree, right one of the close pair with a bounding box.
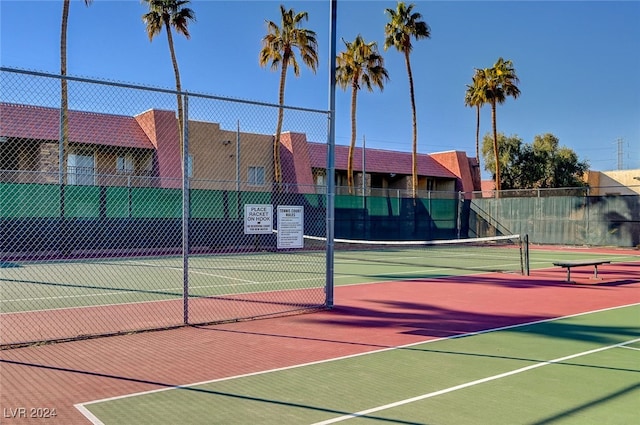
[479,58,520,193]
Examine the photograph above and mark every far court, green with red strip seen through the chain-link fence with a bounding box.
[0,236,636,345]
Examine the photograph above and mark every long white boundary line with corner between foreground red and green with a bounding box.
[74,303,640,425]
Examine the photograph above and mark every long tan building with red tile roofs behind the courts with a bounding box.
[0,103,480,193]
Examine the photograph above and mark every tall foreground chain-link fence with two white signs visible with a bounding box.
[0,68,328,347]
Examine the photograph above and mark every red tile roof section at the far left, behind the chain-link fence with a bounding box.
[0,103,154,149]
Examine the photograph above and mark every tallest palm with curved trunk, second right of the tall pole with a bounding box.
[384,1,431,198]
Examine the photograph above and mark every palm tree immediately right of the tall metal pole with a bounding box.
[336,34,389,193]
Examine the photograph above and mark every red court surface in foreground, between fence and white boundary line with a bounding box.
[0,262,640,425]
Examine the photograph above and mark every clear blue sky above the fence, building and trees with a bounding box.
[0,0,640,177]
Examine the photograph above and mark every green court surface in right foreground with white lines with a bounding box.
[76,304,640,425]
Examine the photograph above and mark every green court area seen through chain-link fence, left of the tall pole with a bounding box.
[2,253,324,311]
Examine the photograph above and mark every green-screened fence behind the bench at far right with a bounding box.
[465,187,640,247]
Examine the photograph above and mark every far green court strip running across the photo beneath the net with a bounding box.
[0,247,638,313]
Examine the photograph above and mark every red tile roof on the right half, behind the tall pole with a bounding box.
[309,142,457,179]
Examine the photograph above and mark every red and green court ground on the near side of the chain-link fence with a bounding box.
[0,243,640,424]
